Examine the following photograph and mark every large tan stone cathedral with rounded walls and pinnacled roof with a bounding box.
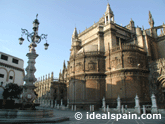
[35,4,165,109]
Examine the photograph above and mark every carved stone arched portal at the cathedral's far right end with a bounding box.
[149,58,165,108]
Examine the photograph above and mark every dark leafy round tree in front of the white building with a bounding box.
[2,83,23,100]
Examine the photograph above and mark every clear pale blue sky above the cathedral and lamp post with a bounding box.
[0,0,165,78]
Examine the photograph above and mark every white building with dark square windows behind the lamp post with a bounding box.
[0,52,25,99]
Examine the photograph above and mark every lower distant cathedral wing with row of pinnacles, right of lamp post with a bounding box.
[35,72,67,107]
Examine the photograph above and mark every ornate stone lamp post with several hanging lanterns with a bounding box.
[19,14,49,106]
